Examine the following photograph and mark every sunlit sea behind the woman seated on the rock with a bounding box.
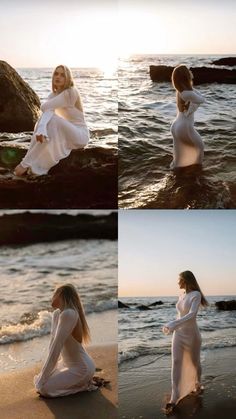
[0,68,118,148]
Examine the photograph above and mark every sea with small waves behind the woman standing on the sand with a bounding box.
[118,295,236,371]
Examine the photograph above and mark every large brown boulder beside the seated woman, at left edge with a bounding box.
[0,61,40,132]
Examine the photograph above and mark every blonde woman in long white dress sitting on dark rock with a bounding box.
[14,65,89,176]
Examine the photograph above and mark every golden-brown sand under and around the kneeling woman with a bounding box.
[0,344,117,419]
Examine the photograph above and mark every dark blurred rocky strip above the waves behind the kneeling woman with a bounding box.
[0,212,117,245]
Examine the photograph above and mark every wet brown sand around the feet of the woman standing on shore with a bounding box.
[119,348,236,419]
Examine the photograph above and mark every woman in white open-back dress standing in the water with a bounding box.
[170,65,205,169]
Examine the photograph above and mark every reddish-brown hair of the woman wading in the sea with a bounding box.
[171,64,193,112]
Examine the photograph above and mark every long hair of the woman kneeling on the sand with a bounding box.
[55,284,90,343]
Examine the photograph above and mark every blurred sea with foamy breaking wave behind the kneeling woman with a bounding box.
[0,240,117,352]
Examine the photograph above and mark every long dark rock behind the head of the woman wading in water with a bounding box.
[150,65,236,84]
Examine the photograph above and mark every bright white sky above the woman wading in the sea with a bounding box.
[118,0,236,56]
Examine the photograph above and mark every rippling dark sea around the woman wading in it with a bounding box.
[118,55,236,209]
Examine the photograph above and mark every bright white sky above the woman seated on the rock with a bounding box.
[0,0,117,71]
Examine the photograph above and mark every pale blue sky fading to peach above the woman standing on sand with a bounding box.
[118,210,236,297]
